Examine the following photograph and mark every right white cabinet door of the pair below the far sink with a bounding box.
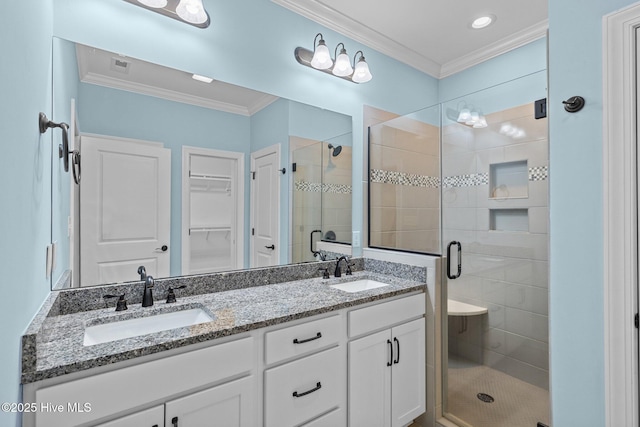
[391,318,426,427]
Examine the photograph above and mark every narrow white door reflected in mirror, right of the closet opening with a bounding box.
[251,144,282,267]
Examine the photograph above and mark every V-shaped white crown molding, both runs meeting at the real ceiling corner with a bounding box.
[271,0,548,79]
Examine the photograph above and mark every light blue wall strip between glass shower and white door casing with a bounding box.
[548,0,633,427]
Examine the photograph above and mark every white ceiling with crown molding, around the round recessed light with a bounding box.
[272,0,547,78]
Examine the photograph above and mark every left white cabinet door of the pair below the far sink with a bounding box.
[349,330,391,427]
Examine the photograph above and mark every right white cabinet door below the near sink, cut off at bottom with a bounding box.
[165,376,255,427]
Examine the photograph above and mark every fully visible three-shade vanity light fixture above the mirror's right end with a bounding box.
[294,33,372,83]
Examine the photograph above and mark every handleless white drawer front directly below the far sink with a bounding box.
[349,293,426,338]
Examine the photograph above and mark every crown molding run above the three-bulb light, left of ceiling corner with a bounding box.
[271,0,440,78]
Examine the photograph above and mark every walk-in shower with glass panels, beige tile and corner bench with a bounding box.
[369,71,549,427]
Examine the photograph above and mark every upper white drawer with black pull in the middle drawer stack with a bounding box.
[264,315,343,365]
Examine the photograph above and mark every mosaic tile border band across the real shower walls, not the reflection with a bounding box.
[369,166,549,188]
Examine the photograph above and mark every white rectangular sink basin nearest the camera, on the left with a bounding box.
[84,308,213,345]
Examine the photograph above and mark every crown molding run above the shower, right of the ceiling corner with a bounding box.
[438,19,549,78]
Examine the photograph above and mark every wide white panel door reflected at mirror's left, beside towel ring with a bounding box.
[80,136,171,286]
